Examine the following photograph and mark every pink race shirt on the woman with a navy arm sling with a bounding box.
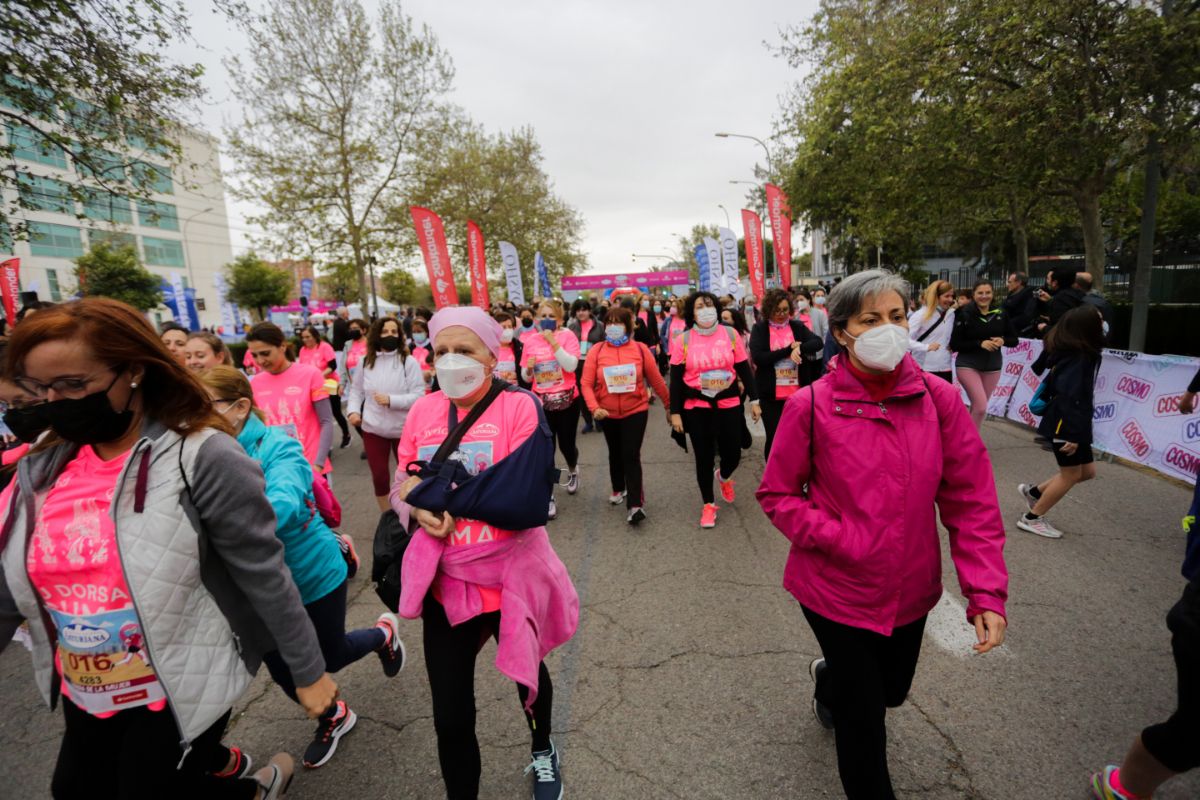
[396,391,538,613]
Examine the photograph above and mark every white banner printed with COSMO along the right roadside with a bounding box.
[988,339,1200,483]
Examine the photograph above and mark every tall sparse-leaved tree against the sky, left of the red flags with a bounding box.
[227,0,454,309]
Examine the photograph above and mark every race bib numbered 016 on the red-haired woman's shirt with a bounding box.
[49,608,167,714]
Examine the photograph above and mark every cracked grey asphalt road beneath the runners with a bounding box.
[0,407,1200,800]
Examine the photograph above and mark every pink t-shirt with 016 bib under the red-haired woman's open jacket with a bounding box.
[22,446,167,717]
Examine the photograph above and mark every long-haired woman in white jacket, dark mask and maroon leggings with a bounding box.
[348,317,425,511]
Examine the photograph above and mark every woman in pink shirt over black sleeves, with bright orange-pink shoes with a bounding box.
[671,291,762,528]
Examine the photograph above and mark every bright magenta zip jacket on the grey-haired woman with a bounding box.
[757,355,1008,636]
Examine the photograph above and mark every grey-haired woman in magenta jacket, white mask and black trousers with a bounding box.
[757,270,1008,800]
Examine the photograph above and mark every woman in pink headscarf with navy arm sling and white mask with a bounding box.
[391,306,578,798]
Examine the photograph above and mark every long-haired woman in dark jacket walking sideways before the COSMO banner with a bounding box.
[1016,306,1104,539]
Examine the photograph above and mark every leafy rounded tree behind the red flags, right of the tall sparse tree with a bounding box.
[400,126,587,296]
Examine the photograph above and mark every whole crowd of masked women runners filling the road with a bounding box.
[0,270,1200,800]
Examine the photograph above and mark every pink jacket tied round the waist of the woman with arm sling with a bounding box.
[400,528,580,710]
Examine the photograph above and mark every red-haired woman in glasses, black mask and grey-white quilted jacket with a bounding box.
[0,297,337,798]
